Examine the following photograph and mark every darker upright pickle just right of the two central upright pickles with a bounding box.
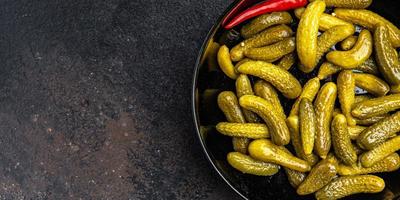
[331,114,357,165]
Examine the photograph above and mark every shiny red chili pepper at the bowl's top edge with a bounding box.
[224,0,308,29]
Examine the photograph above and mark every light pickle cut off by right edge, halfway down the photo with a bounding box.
[351,94,400,119]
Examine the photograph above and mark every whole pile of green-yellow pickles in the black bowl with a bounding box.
[216,0,400,199]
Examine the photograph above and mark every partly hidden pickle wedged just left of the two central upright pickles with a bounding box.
[286,115,319,166]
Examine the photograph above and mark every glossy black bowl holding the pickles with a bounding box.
[193,0,400,200]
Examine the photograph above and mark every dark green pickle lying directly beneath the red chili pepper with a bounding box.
[240,12,293,39]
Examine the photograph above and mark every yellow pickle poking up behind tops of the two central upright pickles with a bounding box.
[290,78,321,115]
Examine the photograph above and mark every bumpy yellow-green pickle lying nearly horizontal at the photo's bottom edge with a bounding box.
[315,175,385,200]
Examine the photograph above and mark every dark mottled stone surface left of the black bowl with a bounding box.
[0,0,239,200]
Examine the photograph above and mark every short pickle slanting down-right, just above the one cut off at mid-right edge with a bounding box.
[353,73,390,97]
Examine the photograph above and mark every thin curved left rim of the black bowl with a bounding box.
[192,0,248,200]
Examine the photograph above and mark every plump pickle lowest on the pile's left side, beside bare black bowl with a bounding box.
[227,152,280,176]
